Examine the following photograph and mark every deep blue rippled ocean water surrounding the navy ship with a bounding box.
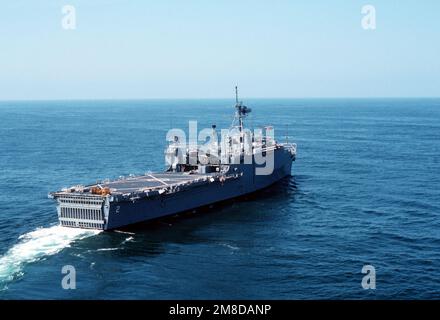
[0,99,440,299]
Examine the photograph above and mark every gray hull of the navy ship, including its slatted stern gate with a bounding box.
[52,147,295,230]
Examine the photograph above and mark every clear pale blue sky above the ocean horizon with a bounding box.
[0,0,440,100]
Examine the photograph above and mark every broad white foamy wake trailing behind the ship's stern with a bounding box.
[0,225,100,289]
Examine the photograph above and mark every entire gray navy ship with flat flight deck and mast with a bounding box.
[49,88,297,230]
